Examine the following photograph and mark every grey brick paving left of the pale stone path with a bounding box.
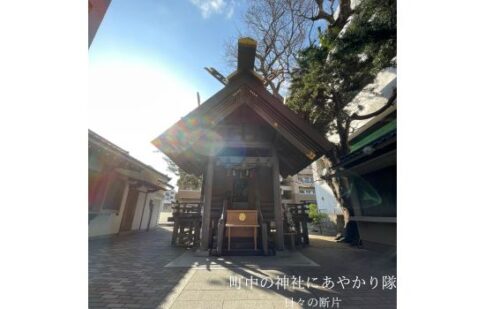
[89,228,189,308]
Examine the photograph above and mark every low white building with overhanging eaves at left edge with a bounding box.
[88,131,172,237]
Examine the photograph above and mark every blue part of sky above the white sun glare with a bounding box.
[89,0,244,97]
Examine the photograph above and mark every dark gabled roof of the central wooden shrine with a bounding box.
[152,41,333,176]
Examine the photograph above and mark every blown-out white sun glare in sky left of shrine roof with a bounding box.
[88,58,197,179]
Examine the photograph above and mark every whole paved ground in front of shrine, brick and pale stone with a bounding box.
[89,227,396,309]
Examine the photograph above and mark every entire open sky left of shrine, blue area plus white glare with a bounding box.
[89,0,245,183]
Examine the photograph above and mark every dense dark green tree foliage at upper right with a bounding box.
[287,0,396,155]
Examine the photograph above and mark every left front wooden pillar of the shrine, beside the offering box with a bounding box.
[200,156,214,250]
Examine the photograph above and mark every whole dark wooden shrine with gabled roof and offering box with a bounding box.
[152,38,333,255]
